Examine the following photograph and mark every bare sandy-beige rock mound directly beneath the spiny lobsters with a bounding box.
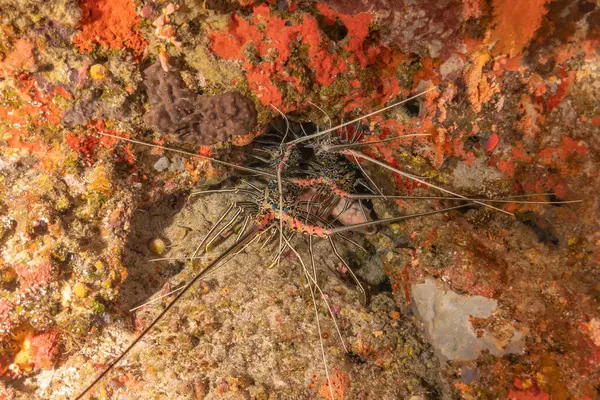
[38,195,450,400]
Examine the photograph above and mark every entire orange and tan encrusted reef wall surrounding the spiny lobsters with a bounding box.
[0,0,600,400]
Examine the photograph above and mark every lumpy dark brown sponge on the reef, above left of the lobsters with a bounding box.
[144,61,256,145]
